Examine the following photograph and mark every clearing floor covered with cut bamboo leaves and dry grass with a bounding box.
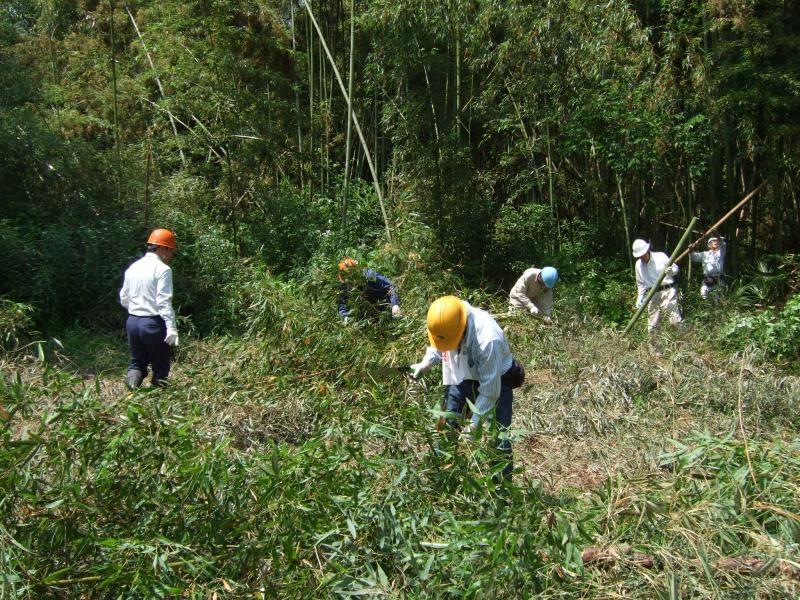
[0,290,800,598]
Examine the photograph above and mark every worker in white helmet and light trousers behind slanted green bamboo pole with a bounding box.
[633,240,683,334]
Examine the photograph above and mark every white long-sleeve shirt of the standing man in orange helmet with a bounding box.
[119,252,178,331]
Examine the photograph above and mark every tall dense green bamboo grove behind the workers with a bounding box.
[0,0,800,328]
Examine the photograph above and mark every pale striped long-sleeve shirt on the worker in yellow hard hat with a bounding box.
[421,302,513,425]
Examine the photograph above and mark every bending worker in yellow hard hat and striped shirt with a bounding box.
[411,296,525,478]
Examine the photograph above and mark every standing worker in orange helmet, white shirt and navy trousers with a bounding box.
[119,229,178,389]
